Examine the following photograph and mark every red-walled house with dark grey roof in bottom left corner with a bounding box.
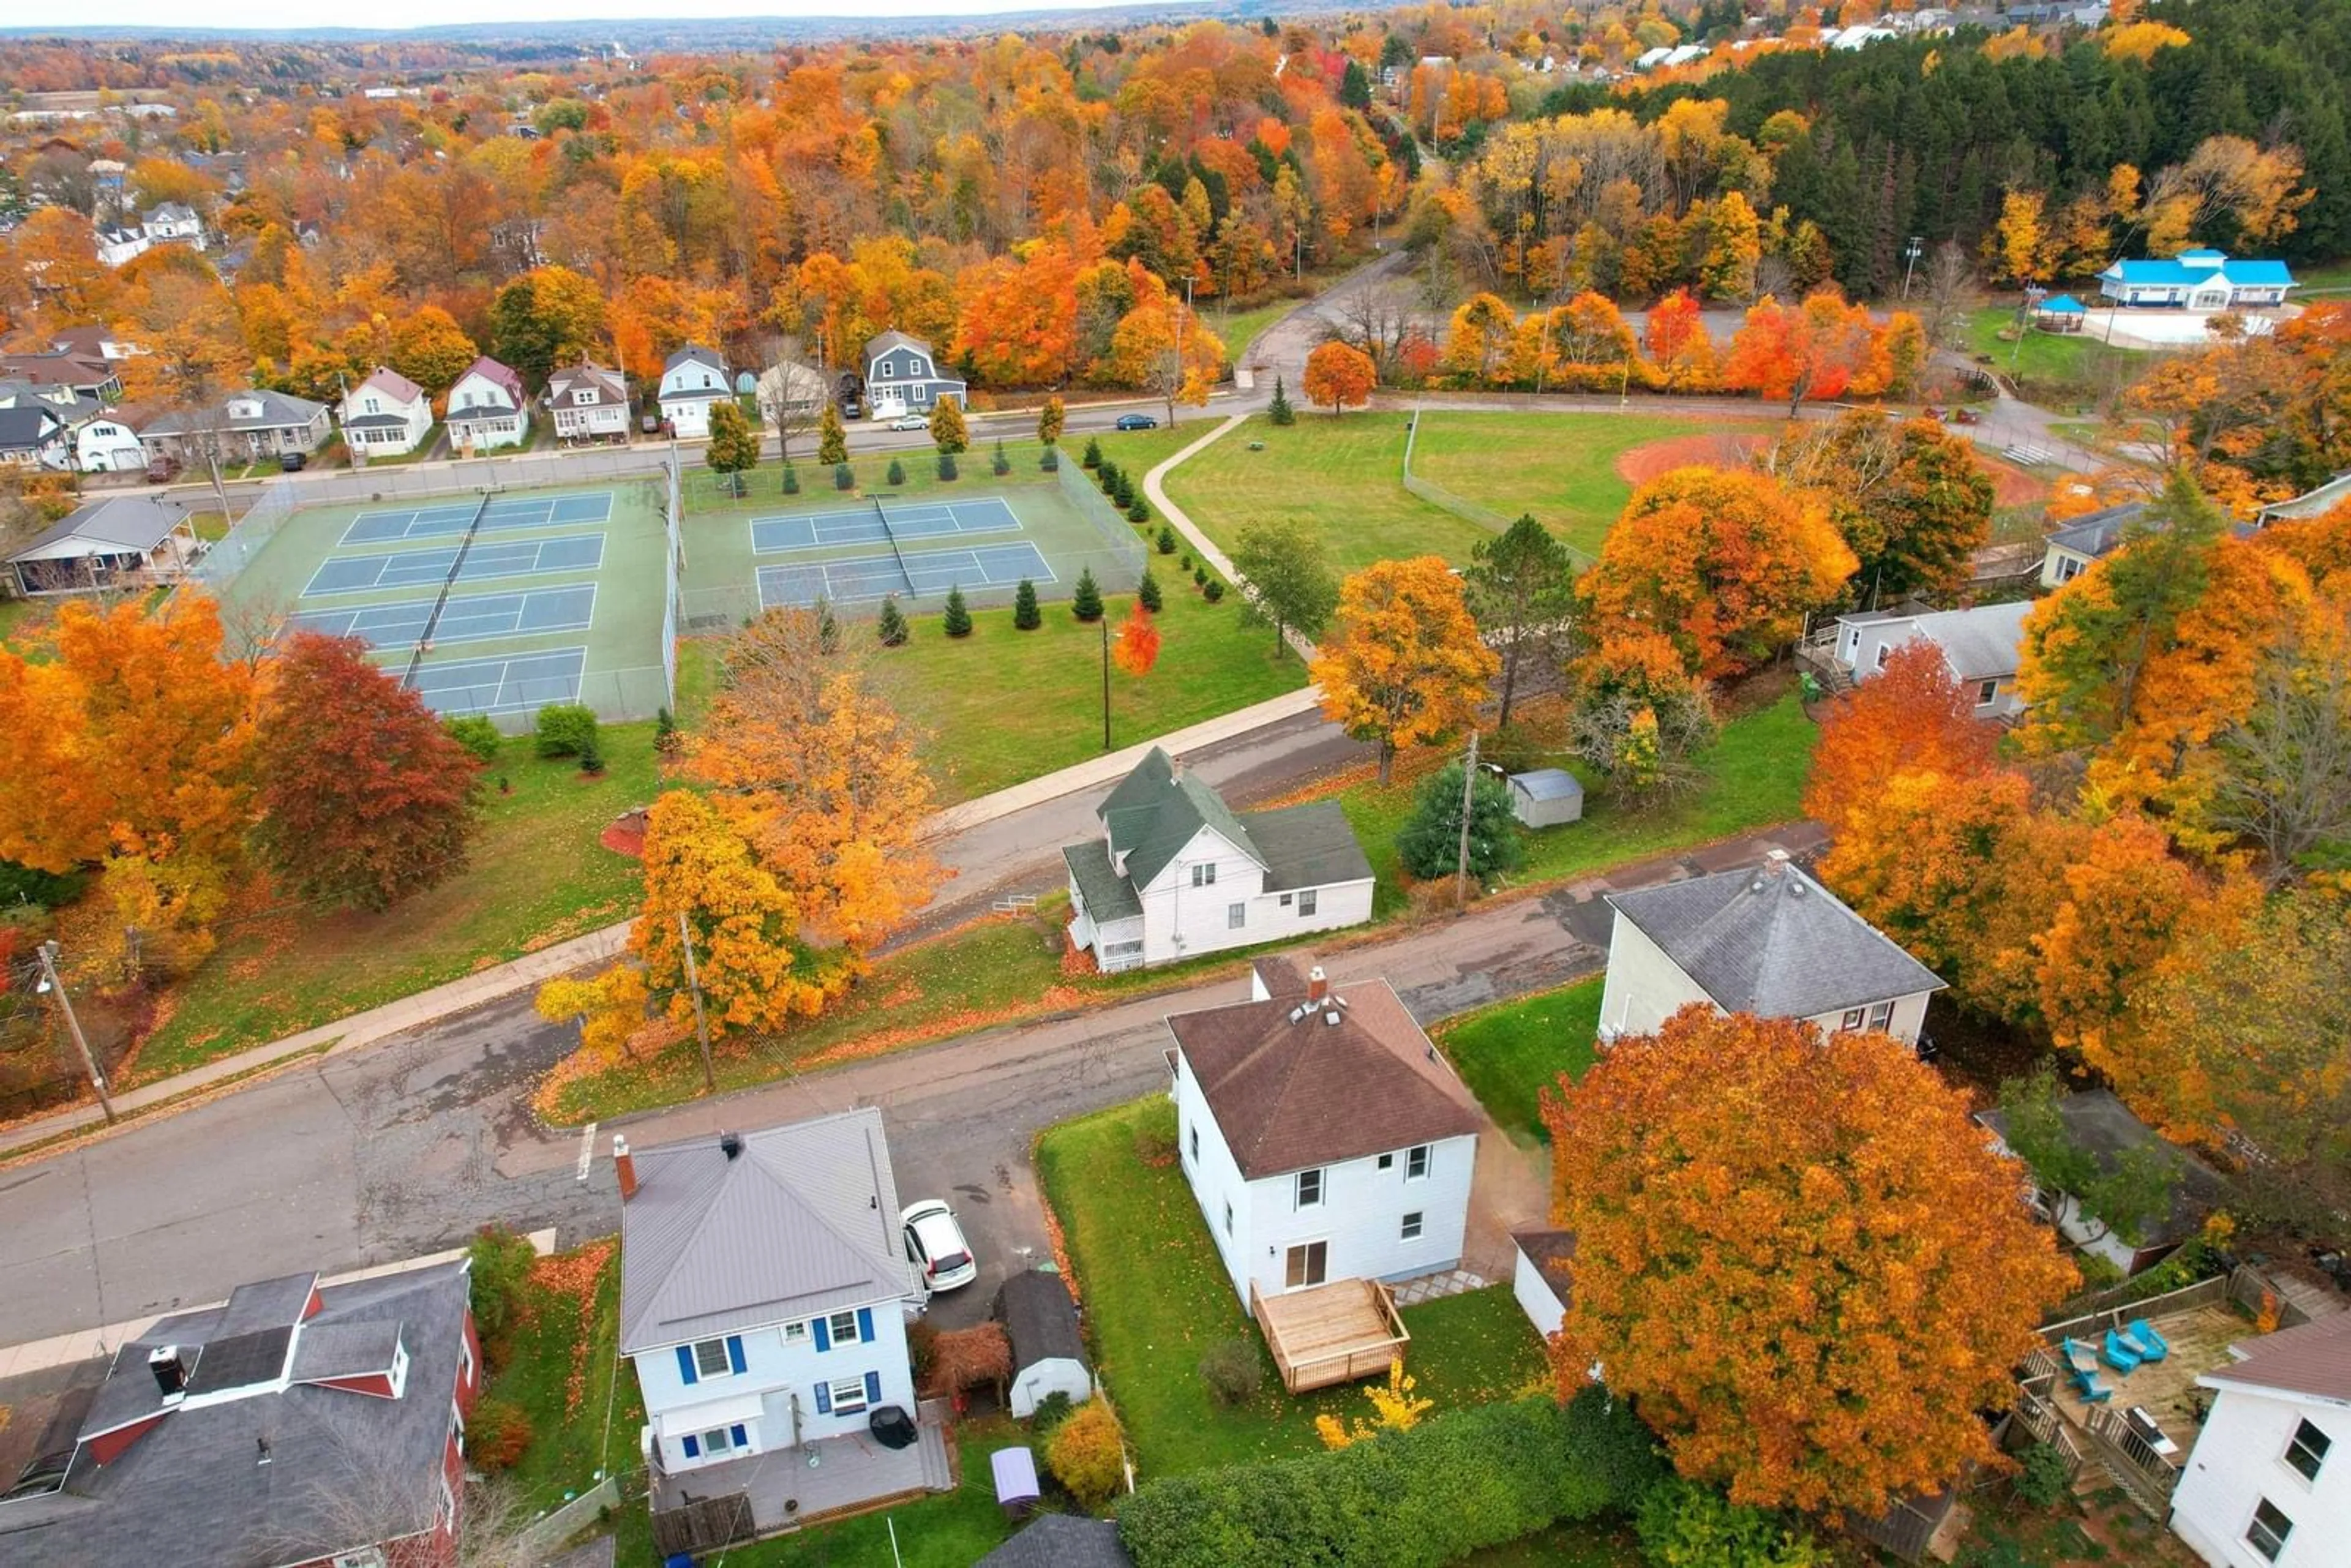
[0,1262,482,1568]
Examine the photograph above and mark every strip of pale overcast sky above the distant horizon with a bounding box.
[48,0,1166,28]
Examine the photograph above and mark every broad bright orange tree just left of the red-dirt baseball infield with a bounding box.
[1580,468,1855,680]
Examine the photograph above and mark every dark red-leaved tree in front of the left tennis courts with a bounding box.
[254,632,482,910]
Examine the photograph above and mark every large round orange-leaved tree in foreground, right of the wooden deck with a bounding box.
[1542,1006,2076,1514]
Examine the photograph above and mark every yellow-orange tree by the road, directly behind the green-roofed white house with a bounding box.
[1312,555,1500,785]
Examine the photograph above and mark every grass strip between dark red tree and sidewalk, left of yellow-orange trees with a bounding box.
[129,724,658,1081]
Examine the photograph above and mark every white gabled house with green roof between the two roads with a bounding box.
[1060,745,1371,973]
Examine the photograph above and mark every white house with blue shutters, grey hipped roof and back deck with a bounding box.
[613,1107,950,1532]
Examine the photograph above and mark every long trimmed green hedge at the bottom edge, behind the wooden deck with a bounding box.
[1119,1389,1665,1568]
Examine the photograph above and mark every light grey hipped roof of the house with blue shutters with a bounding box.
[621,1107,917,1356]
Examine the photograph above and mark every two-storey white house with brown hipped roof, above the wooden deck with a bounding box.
[1168,959,1486,1316]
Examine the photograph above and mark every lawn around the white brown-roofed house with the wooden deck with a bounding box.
[1037,1100,1545,1479]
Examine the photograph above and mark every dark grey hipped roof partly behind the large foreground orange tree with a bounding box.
[1608,863,1944,1018]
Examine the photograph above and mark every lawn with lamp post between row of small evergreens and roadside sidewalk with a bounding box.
[879,571,1307,801]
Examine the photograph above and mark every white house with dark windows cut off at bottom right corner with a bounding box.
[2172,1311,2351,1568]
